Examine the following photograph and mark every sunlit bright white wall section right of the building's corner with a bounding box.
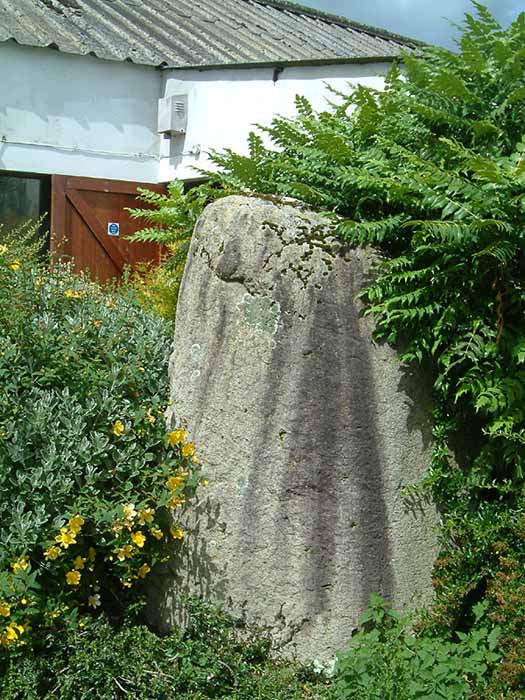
[160,63,391,181]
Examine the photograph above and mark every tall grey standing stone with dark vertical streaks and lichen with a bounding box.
[161,197,437,659]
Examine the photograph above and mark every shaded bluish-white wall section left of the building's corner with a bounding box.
[0,41,162,182]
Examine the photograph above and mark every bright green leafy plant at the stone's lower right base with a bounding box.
[335,595,499,700]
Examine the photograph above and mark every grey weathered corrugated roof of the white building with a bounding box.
[0,0,419,68]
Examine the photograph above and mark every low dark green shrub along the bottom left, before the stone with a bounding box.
[2,601,330,700]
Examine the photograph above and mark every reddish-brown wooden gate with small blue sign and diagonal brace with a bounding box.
[51,175,166,282]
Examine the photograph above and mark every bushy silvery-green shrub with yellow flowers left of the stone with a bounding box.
[0,227,200,654]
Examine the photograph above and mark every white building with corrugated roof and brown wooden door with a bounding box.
[0,0,417,277]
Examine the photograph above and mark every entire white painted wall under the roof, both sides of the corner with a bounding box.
[0,41,390,182]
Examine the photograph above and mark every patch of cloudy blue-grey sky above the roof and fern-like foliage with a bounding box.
[294,0,525,48]
